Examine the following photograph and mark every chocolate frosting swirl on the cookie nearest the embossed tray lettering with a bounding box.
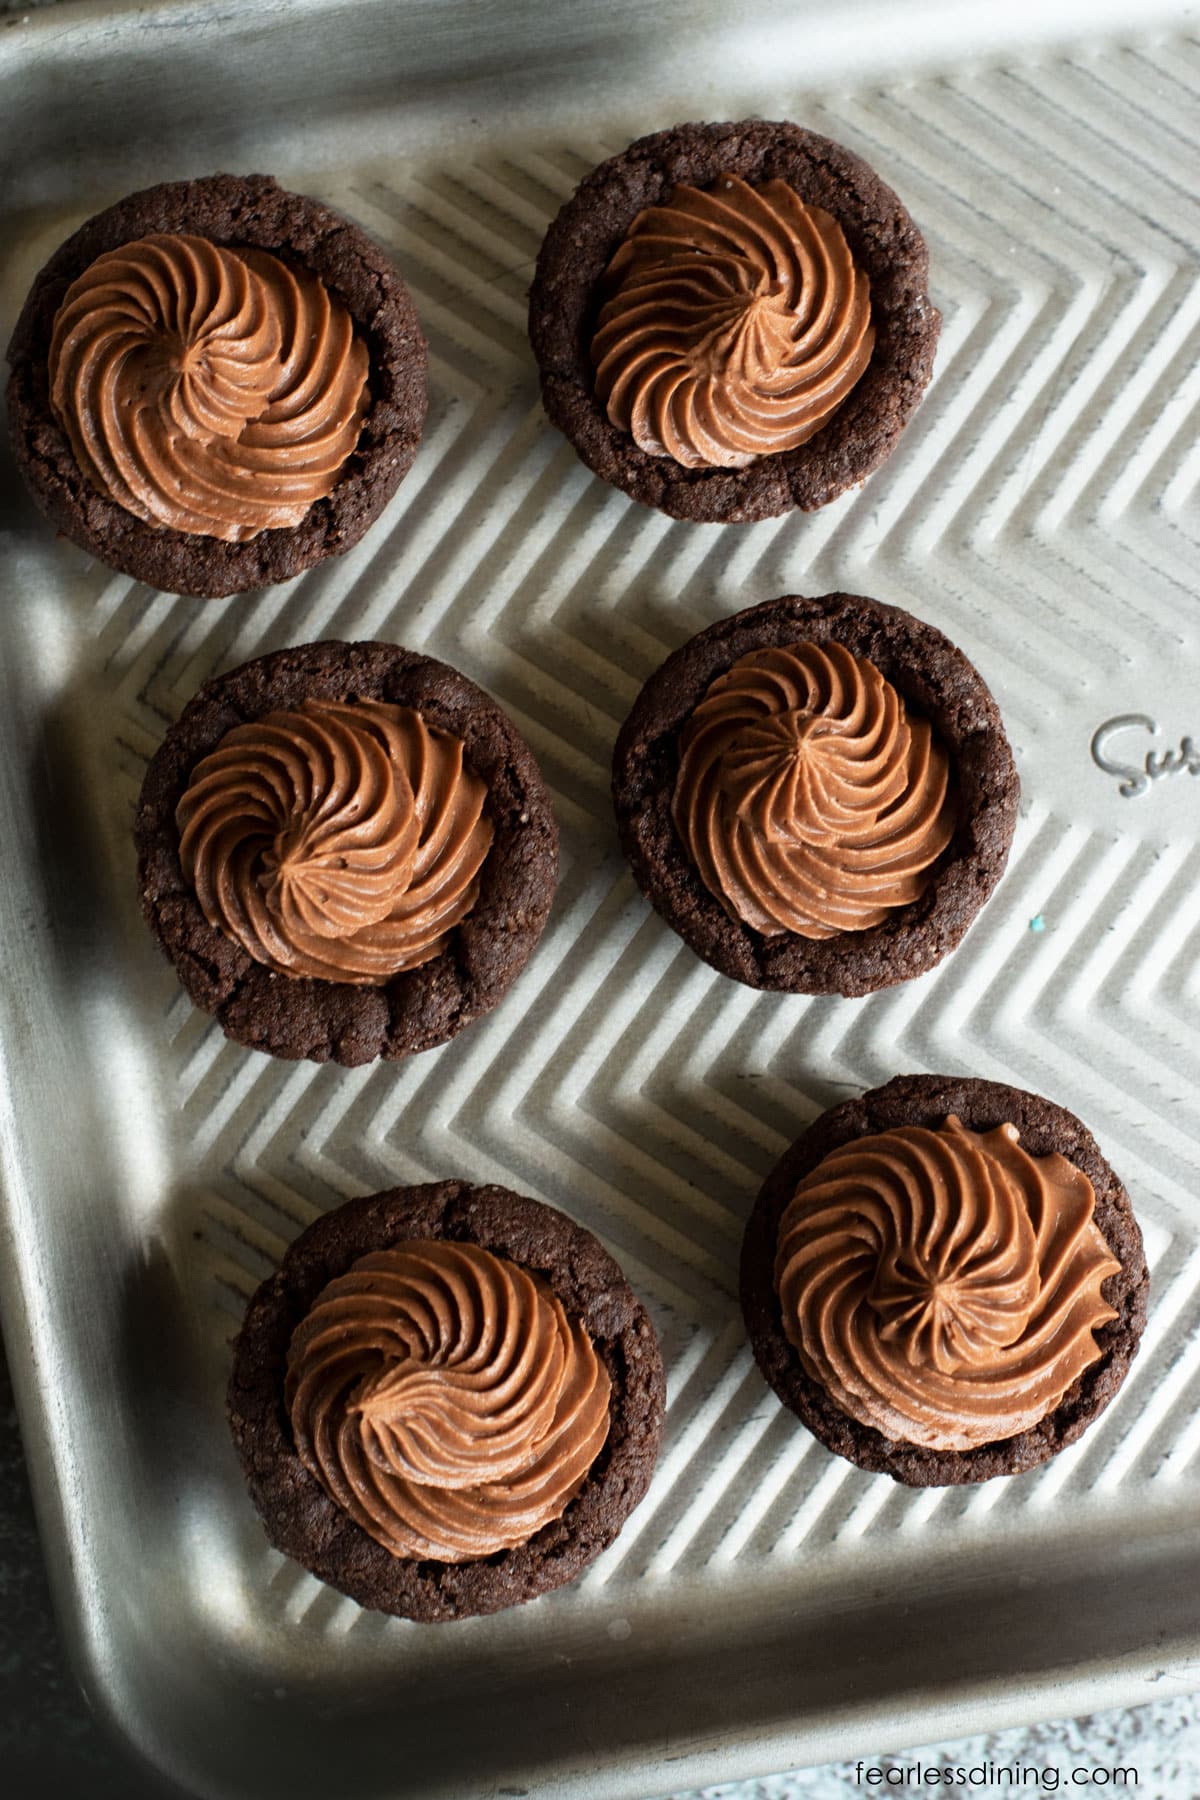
[671,643,954,938]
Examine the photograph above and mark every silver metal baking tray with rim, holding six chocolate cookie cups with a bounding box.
[0,0,1200,1800]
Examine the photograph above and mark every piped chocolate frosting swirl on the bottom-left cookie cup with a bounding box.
[284,1240,612,1562]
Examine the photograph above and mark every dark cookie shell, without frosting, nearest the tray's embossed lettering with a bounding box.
[612,594,1020,995]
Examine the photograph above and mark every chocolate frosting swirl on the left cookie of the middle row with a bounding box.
[175,700,491,986]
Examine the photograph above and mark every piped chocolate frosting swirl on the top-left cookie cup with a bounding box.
[49,234,369,544]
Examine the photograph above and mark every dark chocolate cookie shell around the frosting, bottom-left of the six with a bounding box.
[228,1181,666,1622]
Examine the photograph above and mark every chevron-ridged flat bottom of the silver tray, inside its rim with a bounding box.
[5,14,1200,1791]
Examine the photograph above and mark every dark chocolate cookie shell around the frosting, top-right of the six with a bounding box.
[529,119,941,524]
